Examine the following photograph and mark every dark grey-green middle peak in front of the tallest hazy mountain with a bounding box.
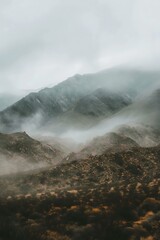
[42,88,132,134]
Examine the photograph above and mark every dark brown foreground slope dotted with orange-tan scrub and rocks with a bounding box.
[0,147,160,240]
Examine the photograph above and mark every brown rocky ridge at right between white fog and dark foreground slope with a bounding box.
[64,123,160,161]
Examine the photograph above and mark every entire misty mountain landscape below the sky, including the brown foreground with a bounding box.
[0,68,160,240]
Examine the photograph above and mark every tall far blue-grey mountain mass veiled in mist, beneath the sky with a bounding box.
[0,68,160,134]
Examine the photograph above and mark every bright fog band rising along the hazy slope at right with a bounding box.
[61,86,160,143]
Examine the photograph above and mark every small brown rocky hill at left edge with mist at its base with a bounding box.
[0,132,64,174]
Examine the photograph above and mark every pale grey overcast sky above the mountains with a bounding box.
[0,0,160,92]
